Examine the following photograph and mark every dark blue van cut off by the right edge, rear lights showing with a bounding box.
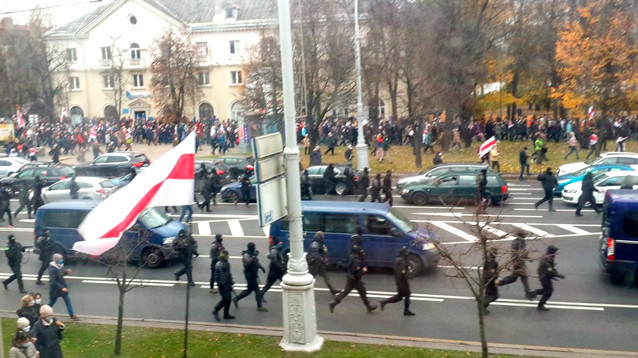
[599,190,638,283]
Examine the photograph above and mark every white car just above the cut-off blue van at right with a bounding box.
[561,170,638,205]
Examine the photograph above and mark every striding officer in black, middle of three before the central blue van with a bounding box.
[329,232,377,313]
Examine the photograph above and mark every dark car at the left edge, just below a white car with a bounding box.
[0,164,75,196]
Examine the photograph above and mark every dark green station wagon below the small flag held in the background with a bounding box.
[400,171,510,205]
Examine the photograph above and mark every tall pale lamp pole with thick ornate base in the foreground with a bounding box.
[278,0,323,352]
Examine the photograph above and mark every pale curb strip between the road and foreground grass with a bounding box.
[0,310,638,358]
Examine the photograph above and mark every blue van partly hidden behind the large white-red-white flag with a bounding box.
[34,200,187,268]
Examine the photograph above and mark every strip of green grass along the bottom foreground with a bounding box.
[2,318,528,358]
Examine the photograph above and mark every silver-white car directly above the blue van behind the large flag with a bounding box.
[42,177,116,203]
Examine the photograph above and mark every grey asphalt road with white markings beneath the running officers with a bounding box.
[0,181,638,351]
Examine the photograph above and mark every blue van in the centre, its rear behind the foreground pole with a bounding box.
[270,200,440,276]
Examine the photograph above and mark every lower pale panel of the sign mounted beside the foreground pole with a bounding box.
[257,176,288,227]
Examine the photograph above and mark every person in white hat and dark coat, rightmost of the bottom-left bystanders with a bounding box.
[29,305,66,358]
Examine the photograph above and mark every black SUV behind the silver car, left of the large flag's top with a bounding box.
[75,152,151,178]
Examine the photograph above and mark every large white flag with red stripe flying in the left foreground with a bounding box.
[73,133,195,256]
